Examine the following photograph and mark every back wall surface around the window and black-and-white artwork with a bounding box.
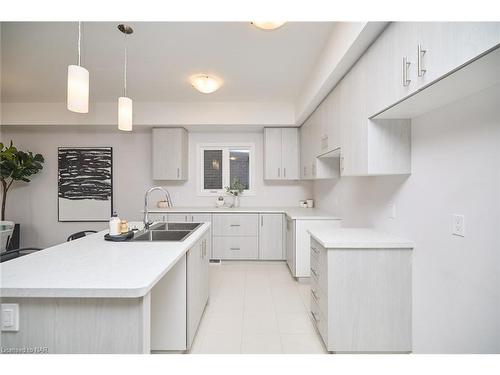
[2,126,312,247]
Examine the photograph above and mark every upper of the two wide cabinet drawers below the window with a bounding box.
[213,214,259,236]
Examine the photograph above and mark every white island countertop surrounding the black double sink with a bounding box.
[0,223,210,298]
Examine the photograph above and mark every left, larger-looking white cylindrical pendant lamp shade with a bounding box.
[68,65,89,113]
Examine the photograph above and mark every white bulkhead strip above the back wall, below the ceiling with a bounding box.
[2,101,295,128]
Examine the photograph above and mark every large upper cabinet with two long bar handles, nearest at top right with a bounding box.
[366,22,500,117]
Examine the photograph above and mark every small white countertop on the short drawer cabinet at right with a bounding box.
[309,228,414,249]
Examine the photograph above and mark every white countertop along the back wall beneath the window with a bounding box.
[149,207,341,220]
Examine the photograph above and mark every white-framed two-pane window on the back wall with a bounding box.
[198,144,255,196]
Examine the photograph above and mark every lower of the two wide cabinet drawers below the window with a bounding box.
[212,236,259,259]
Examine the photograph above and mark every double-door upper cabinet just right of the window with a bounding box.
[264,128,300,180]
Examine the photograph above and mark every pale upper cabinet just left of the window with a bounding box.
[152,128,188,181]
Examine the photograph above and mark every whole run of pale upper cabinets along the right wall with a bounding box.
[301,22,500,179]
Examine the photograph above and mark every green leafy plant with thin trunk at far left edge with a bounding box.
[0,141,44,251]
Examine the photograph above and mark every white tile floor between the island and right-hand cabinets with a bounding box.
[190,262,325,354]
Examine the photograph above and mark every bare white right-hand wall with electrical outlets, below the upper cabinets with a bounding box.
[314,86,500,353]
